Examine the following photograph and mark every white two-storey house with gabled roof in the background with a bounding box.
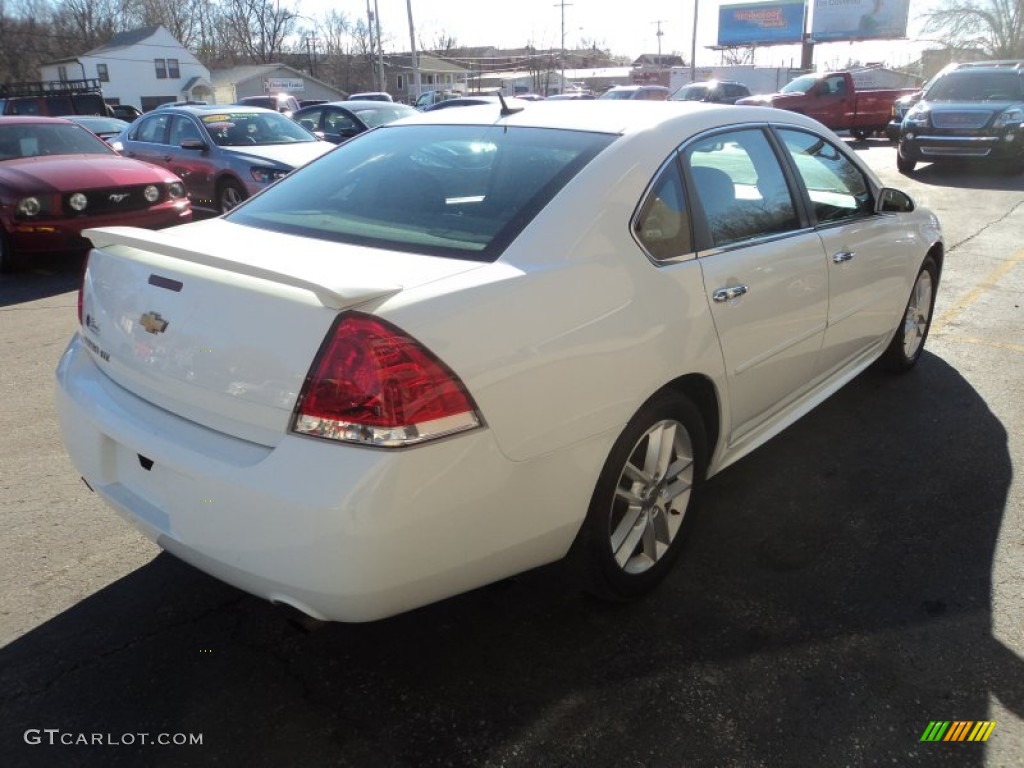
[39,27,213,111]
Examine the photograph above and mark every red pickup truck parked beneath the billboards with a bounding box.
[736,72,916,139]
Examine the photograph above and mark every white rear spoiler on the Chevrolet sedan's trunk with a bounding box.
[82,226,401,309]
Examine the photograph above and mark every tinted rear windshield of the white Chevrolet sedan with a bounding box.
[226,124,614,261]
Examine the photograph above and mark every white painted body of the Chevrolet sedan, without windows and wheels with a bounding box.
[51,101,941,621]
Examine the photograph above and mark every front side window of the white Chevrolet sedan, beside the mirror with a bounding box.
[778,128,874,223]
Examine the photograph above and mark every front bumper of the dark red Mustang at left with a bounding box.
[6,200,191,254]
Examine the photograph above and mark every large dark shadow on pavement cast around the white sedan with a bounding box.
[0,354,1024,768]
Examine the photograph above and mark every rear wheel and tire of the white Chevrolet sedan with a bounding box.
[569,392,708,602]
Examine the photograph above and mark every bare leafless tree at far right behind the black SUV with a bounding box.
[924,0,1024,58]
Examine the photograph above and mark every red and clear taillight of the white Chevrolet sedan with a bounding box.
[293,312,480,447]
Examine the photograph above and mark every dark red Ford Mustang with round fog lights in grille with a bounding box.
[0,117,191,271]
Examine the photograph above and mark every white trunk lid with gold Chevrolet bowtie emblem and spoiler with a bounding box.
[81,219,480,445]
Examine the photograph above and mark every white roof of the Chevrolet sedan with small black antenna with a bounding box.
[389,99,821,134]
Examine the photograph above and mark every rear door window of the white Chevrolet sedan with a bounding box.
[685,128,800,247]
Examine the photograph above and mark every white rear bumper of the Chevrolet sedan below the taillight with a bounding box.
[56,335,607,622]
